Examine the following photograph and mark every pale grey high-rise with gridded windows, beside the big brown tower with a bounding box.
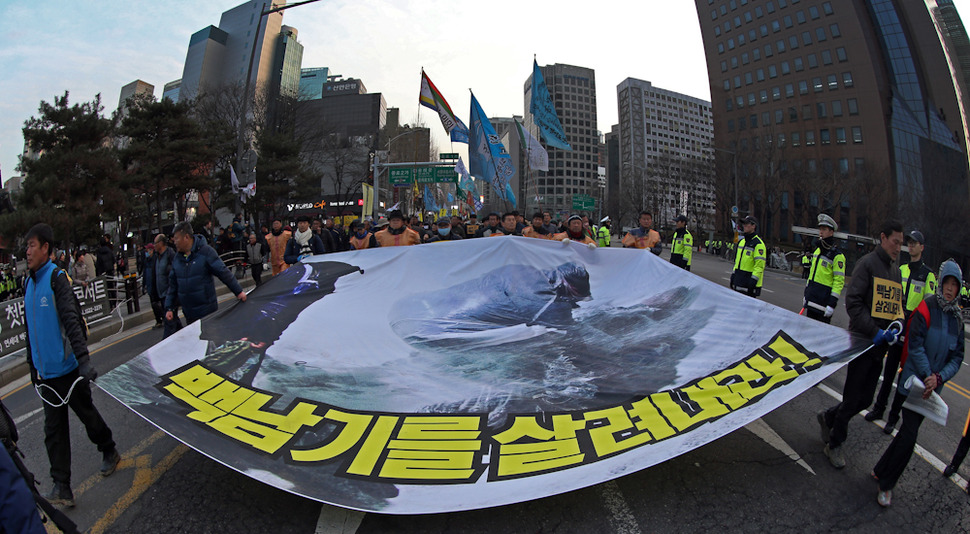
[616,78,714,232]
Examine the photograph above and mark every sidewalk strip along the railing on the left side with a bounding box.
[0,274,255,388]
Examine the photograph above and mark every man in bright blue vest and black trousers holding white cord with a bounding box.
[24,223,121,507]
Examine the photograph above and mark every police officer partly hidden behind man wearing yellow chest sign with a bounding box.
[866,230,936,434]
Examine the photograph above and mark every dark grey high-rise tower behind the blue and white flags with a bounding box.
[519,63,599,219]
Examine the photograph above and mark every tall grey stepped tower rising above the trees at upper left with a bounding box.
[179,0,292,99]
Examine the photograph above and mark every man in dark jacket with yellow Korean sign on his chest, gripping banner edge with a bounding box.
[817,221,903,469]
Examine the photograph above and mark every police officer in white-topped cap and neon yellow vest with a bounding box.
[804,213,845,323]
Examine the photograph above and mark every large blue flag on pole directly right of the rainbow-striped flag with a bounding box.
[468,94,515,200]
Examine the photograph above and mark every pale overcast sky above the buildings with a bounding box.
[0,0,970,184]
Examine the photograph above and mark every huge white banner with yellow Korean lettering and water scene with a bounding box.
[99,237,868,514]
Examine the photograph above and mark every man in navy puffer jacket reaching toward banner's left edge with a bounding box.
[165,222,246,324]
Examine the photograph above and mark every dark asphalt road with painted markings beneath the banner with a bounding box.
[3,251,970,533]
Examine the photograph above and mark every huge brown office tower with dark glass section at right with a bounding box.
[695,0,970,261]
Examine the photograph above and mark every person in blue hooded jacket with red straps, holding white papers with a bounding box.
[872,260,964,506]
